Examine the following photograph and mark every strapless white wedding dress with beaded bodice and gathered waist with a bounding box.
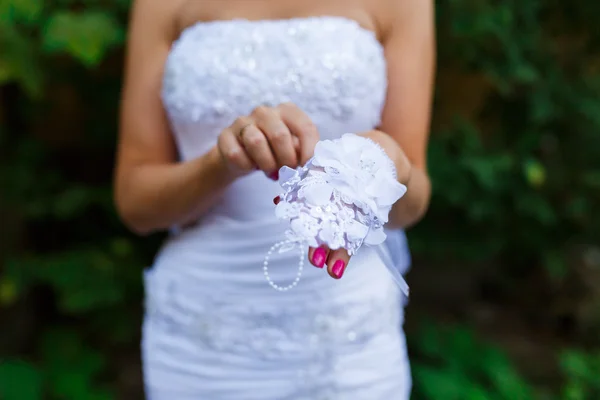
[142,17,411,400]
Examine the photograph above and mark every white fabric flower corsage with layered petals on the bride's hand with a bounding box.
[275,134,406,254]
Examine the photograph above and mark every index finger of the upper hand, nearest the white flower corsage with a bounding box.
[278,103,319,165]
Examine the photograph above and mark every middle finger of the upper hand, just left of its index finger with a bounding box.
[252,107,298,168]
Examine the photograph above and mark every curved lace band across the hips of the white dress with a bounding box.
[146,288,398,360]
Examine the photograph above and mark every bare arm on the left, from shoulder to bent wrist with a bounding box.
[114,0,233,234]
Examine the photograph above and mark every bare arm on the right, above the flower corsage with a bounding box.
[373,0,435,227]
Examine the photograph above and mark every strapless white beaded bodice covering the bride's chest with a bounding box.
[163,17,386,159]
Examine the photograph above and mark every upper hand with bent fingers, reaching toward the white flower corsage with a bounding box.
[217,103,319,180]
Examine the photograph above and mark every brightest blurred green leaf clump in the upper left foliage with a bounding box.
[43,11,124,67]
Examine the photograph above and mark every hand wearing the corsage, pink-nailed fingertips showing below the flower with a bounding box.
[273,130,412,279]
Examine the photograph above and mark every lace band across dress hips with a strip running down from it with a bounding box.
[146,268,402,400]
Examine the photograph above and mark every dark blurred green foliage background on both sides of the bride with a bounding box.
[0,0,600,400]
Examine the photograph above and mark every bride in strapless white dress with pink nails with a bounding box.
[115,0,434,400]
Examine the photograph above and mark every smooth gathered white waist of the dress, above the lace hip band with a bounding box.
[153,181,409,297]
